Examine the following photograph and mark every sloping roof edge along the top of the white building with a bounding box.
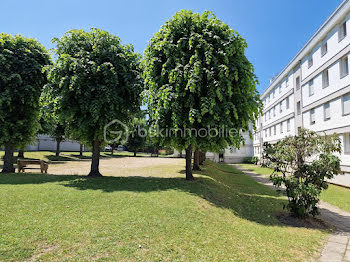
[261,0,350,98]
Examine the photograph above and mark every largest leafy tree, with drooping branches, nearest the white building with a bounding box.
[143,10,261,180]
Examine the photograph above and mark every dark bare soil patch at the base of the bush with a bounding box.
[276,213,333,230]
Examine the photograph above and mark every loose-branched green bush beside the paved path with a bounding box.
[264,129,341,218]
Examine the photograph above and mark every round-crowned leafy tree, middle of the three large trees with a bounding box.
[48,29,141,176]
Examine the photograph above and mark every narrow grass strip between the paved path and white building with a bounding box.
[238,164,350,215]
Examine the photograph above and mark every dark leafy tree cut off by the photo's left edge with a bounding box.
[0,33,50,173]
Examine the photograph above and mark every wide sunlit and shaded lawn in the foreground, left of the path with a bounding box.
[0,160,329,261]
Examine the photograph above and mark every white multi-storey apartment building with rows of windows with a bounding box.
[253,0,350,176]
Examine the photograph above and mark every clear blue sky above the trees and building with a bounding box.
[0,0,341,92]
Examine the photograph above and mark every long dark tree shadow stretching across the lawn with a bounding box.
[0,164,285,226]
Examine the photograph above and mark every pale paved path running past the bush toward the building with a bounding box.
[233,165,350,262]
